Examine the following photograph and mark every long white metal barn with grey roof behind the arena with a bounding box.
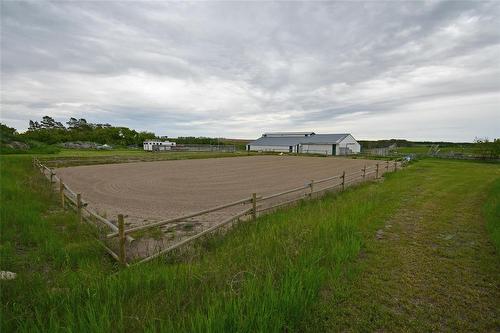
[247,132,361,155]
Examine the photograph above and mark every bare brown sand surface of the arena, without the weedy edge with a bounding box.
[56,156,377,223]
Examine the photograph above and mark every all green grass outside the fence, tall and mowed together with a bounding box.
[0,156,500,332]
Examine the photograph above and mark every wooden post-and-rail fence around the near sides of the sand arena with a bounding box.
[33,158,404,266]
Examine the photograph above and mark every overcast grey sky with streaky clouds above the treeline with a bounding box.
[1,1,500,141]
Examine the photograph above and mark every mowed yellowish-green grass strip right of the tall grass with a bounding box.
[302,160,500,332]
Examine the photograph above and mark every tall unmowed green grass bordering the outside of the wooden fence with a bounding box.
[0,157,499,332]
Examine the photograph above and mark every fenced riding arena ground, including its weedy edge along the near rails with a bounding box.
[51,156,394,259]
